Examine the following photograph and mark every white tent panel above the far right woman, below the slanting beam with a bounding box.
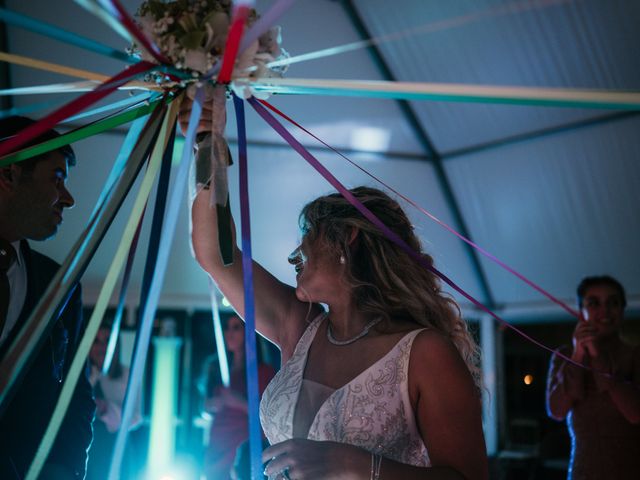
[445,112,640,312]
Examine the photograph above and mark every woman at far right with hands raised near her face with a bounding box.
[547,276,640,480]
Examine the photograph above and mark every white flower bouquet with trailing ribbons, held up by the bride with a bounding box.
[129,0,288,264]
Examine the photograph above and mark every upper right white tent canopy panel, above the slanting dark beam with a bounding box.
[355,0,640,155]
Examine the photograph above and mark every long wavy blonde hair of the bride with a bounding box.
[299,187,482,388]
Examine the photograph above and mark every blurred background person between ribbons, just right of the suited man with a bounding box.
[87,322,142,480]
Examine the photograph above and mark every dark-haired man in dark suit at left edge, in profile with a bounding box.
[0,117,95,480]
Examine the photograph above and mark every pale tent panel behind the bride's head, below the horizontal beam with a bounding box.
[37,136,480,307]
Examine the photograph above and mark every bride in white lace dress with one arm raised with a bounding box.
[188,97,488,480]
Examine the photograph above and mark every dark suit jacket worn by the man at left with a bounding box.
[0,241,95,480]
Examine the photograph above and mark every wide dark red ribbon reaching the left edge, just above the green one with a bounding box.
[0,62,157,157]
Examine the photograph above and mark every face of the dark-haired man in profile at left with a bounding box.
[12,151,75,240]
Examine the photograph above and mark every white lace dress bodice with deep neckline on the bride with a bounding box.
[260,314,430,466]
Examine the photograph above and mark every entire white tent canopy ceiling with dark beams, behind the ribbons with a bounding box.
[5,0,640,320]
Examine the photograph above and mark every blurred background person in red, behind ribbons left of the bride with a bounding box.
[204,315,275,480]
